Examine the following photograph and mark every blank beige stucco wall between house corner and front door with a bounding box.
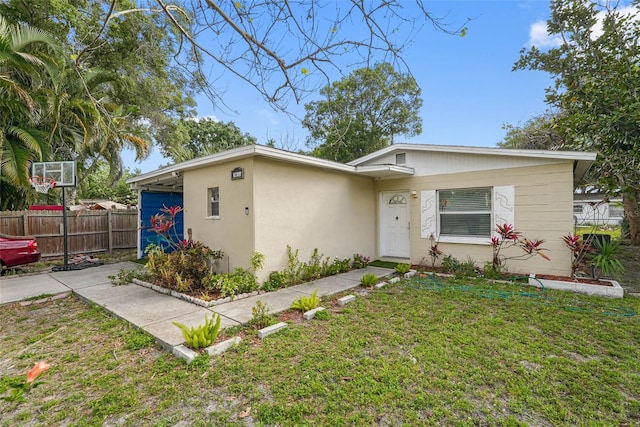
[254,158,376,280]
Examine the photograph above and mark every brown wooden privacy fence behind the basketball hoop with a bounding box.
[0,210,138,257]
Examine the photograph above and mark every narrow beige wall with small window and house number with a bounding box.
[183,159,254,269]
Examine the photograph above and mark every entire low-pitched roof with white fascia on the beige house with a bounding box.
[127,144,596,191]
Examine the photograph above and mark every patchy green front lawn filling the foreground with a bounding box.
[0,281,640,426]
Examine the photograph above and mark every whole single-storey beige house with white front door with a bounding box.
[127,144,595,277]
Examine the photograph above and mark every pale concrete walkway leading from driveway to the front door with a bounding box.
[0,262,393,350]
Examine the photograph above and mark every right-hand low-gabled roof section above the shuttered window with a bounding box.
[347,143,596,187]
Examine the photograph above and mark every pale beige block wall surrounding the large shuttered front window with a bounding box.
[376,161,573,275]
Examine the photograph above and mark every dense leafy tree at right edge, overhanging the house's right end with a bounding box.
[514,0,640,244]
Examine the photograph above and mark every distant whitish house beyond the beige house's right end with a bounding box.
[573,193,624,225]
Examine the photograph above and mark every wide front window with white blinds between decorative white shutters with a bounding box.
[438,187,493,238]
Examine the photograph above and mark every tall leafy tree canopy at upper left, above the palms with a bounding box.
[0,0,195,142]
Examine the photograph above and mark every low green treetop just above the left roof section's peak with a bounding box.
[163,119,257,163]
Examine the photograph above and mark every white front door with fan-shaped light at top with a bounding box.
[380,192,410,258]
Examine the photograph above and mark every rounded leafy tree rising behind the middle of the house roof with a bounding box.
[302,63,422,162]
